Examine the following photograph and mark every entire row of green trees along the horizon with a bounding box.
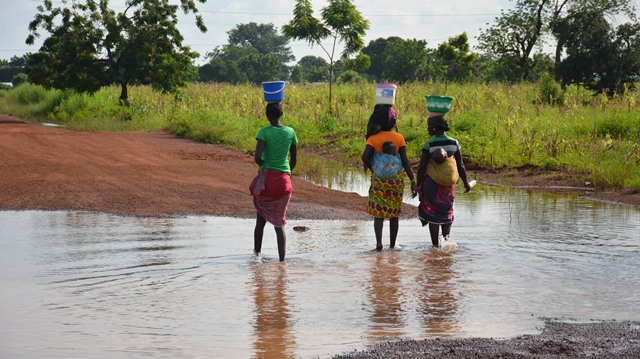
[0,0,640,103]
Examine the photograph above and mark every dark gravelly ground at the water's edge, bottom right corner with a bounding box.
[333,318,640,359]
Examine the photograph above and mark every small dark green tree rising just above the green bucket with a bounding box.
[437,32,476,81]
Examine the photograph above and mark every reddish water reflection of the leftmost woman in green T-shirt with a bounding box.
[251,262,296,359]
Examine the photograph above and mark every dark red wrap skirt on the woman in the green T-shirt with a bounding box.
[249,168,293,227]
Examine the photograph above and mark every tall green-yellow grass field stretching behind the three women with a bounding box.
[0,79,640,190]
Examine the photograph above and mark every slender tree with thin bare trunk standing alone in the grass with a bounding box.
[282,0,369,103]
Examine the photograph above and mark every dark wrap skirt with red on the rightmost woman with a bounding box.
[418,176,455,226]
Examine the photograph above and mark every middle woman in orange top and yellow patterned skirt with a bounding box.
[362,105,417,251]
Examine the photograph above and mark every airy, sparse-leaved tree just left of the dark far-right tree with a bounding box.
[478,0,550,80]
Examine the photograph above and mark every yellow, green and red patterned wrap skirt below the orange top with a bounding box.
[367,173,404,218]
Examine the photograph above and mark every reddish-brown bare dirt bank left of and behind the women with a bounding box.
[0,115,416,220]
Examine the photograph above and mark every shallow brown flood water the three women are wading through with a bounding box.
[0,169,640,358]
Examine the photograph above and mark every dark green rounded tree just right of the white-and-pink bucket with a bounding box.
[382,39,429,83]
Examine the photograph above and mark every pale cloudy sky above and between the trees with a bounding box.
[0,0,513,64]
